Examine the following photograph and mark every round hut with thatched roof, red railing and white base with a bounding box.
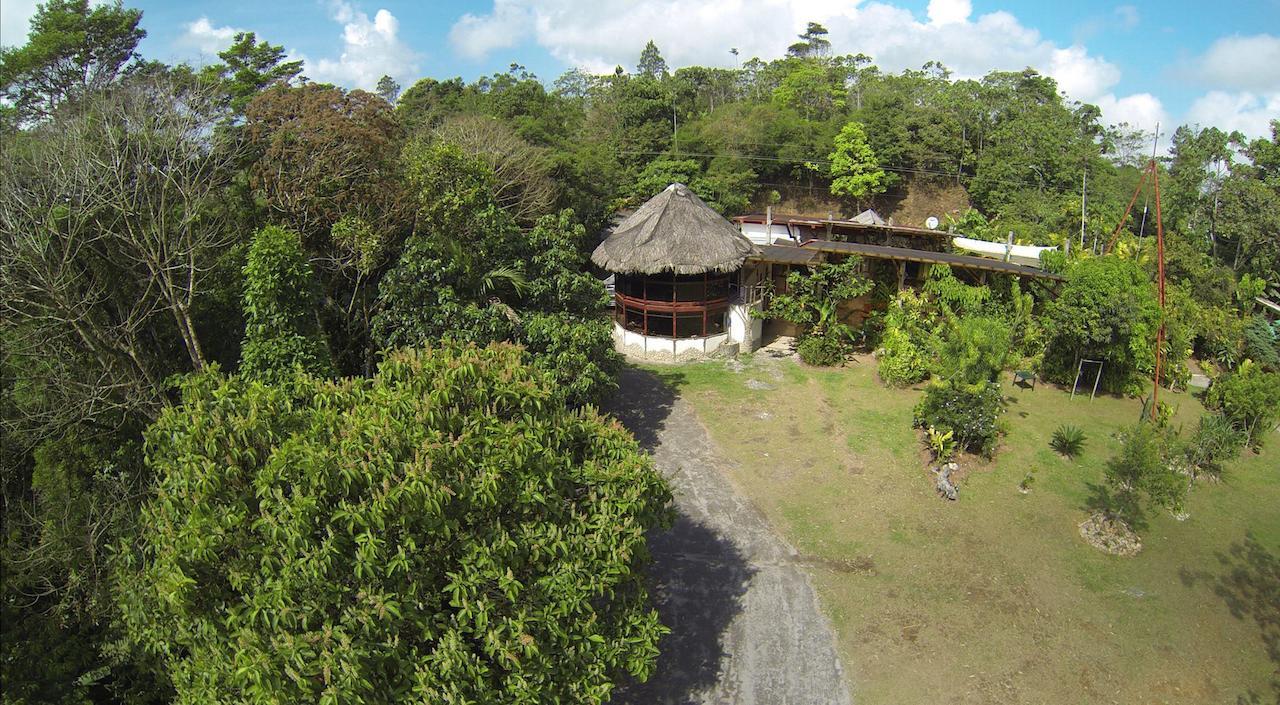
[591,184,762,362]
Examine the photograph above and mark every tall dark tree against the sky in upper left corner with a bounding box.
[0,0,147,123]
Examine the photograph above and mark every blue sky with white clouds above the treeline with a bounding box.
[0,0,1280,137]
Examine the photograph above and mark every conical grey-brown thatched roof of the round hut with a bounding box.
[591,183,753,274]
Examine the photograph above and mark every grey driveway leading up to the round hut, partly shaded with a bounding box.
[608,368,852,705]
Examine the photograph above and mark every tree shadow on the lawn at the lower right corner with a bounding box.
[1179,532,1280,705]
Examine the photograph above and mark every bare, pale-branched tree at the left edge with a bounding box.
[0,77,238,413]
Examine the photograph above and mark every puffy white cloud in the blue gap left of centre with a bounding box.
[306,1,419,90]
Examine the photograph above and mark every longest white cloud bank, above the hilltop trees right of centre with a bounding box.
[449,0,1164,129]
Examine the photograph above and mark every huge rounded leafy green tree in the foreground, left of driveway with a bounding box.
[118,344,671,704]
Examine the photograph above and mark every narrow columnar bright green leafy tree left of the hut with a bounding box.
[241,225,333,381]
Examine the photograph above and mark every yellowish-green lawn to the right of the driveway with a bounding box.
[653,357,1280,705]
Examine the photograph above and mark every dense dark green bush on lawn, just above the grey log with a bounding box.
[915,383,1005,458]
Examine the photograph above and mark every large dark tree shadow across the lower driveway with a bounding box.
[612,514,755,705]
